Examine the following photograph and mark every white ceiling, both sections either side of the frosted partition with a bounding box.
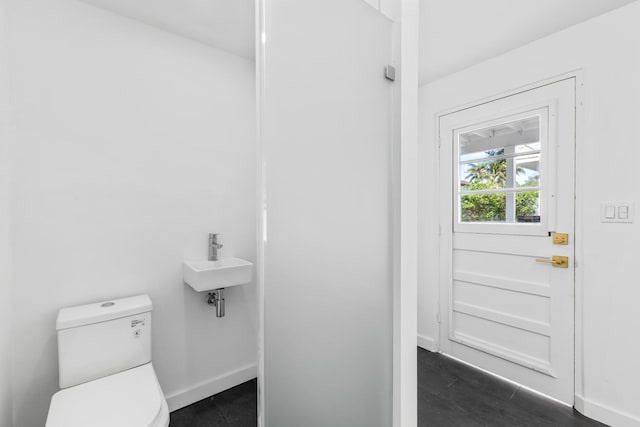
[84,0,636,84]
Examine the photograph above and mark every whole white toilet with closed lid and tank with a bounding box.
[46,295,169,427]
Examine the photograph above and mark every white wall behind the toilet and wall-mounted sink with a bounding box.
[10,0,257,427]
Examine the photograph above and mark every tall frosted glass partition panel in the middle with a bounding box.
[258,0,394,427]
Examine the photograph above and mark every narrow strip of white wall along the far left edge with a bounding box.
[0,0,12,427]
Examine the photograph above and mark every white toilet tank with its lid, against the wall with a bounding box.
[56,295,152,388]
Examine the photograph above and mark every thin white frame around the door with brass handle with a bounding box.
[433,69,585,412]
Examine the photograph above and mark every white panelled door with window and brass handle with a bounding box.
[439,78,575,404]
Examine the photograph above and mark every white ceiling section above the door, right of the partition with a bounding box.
[420,0,635,84]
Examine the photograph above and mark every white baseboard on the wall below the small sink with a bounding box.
[166,364,258,412]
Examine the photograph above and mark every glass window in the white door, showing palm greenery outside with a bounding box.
[454,109,547,233]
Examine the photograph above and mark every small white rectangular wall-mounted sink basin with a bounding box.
[182,258,253,292]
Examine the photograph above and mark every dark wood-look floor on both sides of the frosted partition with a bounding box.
[170,349,604,427]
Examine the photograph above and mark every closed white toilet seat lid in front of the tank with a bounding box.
[46,363,164,427]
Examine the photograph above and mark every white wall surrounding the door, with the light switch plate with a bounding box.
[419,2,640,426]
